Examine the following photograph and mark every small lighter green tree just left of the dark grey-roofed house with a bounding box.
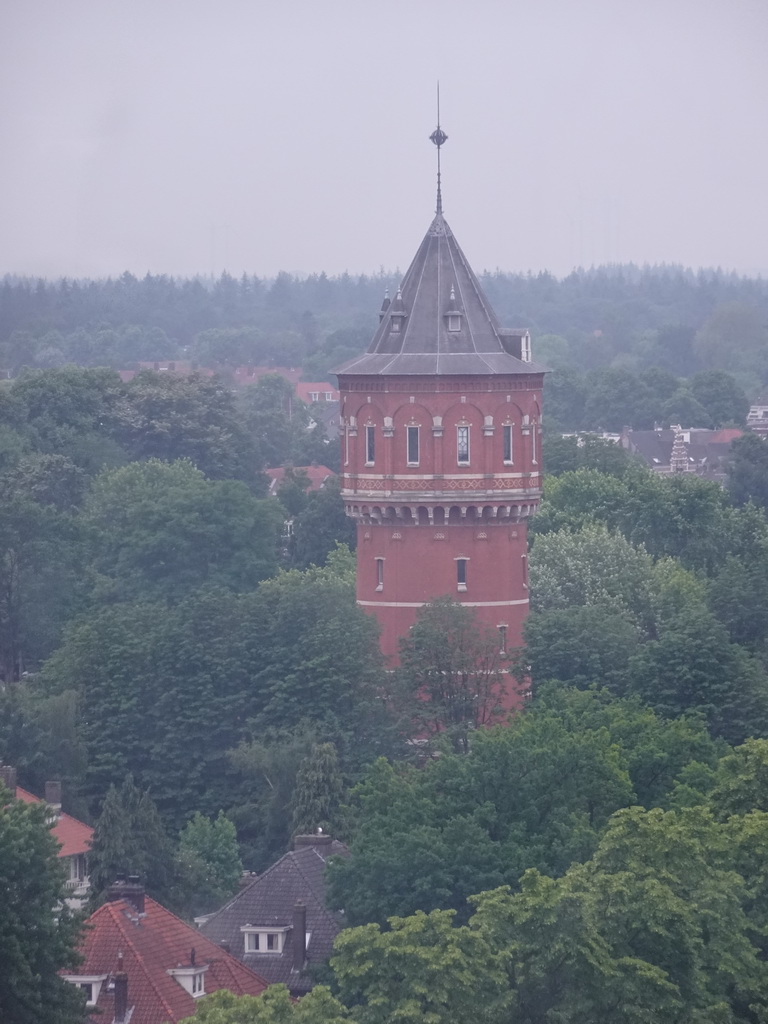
[175,811,243,916]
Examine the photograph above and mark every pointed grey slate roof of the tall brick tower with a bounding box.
[334,213,544,376]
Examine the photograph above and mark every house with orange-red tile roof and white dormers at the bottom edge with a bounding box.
[62,876,274,1024]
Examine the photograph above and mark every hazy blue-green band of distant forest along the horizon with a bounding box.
[0,264,768,397]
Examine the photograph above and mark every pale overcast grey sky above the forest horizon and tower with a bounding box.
[0,0,768,276]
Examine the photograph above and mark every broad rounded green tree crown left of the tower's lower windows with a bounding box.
[84,459,282,600]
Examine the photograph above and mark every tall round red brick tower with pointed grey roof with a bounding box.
[337,128,544,665]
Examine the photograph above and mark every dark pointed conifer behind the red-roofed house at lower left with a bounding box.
[88,775,174,903]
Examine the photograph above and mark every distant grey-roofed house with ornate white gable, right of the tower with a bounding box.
[621,421,745,483]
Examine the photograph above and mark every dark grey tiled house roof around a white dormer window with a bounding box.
[201,836,348,994]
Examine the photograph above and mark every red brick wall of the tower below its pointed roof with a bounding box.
[339,374,542,660]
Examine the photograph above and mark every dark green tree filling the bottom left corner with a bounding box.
[0,786,85,1024]
